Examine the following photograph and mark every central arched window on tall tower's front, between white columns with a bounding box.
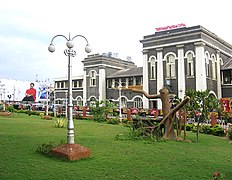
[166,54,176,78]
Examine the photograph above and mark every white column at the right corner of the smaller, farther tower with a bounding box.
[98,68,106,101]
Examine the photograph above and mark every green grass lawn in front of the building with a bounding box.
[0,114,232,180]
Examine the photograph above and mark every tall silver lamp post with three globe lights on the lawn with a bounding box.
[48,34,92,144]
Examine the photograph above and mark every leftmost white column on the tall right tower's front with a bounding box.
[143,50,149,109]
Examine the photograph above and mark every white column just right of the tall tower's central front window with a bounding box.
[177,45,185,99]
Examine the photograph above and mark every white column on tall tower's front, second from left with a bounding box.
[156,48,164,109]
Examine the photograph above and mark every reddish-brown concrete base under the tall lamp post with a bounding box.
[51,144,91,161]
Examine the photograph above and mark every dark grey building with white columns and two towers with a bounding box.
[54,26,232,109]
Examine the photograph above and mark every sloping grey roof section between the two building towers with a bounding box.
[107,67,143,78]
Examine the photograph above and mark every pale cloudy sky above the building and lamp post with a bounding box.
[0,0,232,81]
